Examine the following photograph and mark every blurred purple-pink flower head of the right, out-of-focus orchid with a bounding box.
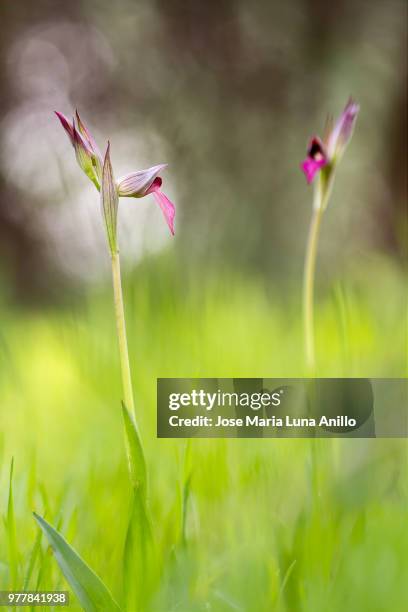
[300,98,359,184]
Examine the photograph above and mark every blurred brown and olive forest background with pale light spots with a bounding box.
[0,0,407,304]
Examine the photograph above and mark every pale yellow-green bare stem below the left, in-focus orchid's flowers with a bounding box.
[112,251,135,414]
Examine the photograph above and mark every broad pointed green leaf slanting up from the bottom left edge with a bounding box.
[34,512,120,612]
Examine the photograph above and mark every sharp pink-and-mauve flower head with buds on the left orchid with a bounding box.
[55,111,175,240]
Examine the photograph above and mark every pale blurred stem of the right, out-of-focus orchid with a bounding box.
[303,206,323,374]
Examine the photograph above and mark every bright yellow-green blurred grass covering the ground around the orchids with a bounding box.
[0,251,408,612]
